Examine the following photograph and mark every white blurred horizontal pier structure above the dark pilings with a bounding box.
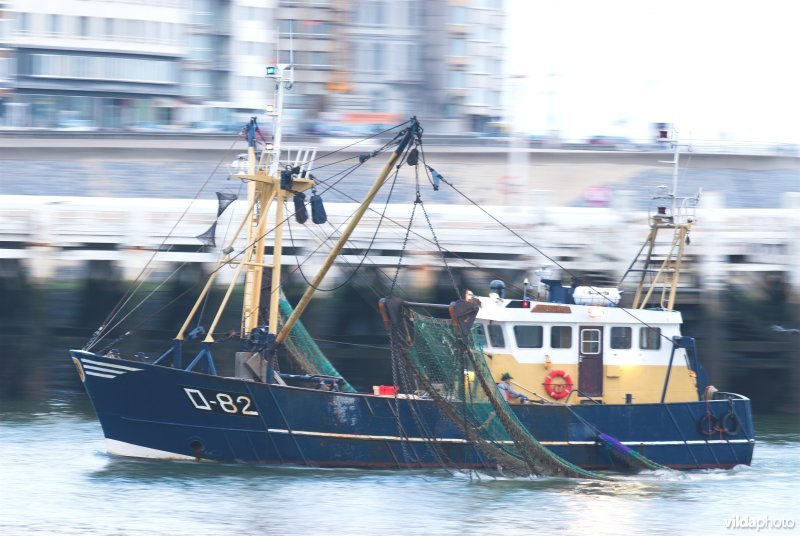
[0,192,800,296]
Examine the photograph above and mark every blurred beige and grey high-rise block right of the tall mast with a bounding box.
[276,0,505,133]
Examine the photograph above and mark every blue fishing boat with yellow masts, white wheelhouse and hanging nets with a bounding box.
[70,65,755,478]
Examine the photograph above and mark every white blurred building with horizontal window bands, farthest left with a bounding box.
[3,0,185,129]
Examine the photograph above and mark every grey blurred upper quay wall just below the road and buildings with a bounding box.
[0,133,800,208]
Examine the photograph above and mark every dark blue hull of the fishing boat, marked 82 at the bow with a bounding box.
[72,351,755,469]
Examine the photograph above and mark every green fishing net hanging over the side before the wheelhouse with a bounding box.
[384,297,609,480]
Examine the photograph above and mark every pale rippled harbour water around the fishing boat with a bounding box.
[0,394,800,536]
